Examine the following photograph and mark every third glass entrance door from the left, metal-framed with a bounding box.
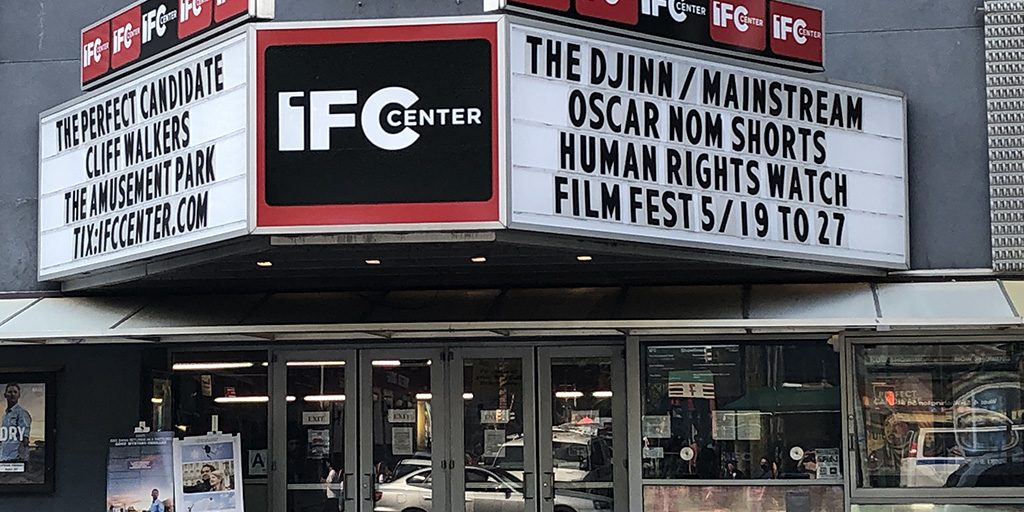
[450,348,537,512]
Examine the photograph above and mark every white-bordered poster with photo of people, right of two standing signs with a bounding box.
[174,434,243,512]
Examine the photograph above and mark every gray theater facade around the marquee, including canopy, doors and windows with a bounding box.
[0,0,1024,512]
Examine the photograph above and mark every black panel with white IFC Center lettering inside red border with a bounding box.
[264,39,495,206]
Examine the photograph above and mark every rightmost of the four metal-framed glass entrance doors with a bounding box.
[539,347,626,512]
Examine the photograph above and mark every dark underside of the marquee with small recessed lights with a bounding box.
[72,232,870,294]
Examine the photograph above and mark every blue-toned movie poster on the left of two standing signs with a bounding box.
[106,432,176,512]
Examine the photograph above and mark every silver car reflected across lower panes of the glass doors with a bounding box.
[374,466,612,512]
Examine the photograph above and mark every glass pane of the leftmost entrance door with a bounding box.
[278,351,355,512]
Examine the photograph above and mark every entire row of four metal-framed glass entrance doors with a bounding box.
[270,346,627,512]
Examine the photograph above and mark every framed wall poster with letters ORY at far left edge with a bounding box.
[0,375,51,485]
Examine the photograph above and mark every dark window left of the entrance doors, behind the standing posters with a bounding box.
[171,351,269,478]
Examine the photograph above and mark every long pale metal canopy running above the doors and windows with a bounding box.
[0,281,1024,344]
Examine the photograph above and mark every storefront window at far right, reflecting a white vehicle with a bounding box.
[855,343,1024,487]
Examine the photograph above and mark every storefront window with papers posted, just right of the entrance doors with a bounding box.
[642,342,843,483]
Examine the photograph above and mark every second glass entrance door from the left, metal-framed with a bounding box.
[357,348,451,512]
